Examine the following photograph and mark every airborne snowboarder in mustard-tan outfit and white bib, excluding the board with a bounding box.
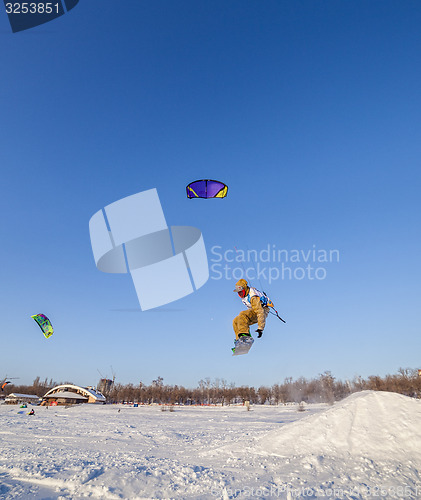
[232,279,269,340]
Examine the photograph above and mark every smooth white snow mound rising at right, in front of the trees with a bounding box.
[254,391,421,461]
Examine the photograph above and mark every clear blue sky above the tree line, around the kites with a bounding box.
[0,0,421,387]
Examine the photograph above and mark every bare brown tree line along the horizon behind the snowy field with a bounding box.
[3,368,421,405]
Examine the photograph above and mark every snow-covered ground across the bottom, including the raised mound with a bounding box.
[0,391,421,500]
